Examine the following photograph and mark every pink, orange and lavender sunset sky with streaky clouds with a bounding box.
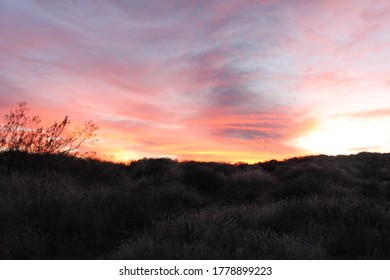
[0,0,390,163]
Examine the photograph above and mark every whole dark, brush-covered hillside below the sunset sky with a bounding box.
[0,153,390,259]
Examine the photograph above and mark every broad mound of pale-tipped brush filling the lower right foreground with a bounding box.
[108,196,390,259]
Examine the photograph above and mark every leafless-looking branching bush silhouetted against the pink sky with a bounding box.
[0,101,98,156]
